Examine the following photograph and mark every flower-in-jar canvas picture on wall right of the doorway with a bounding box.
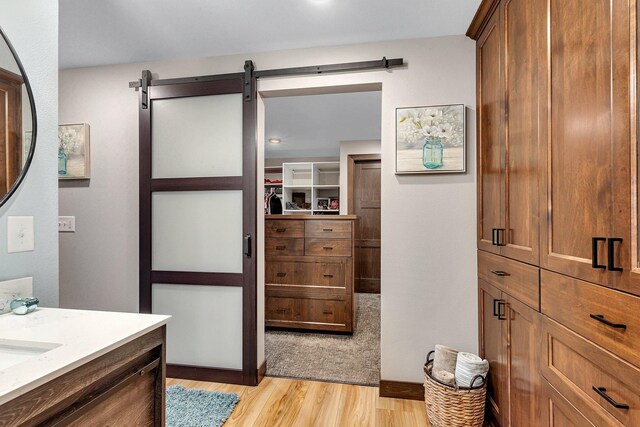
[396,104,466,175]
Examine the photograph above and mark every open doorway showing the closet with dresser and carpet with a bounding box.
[264,90,382,386]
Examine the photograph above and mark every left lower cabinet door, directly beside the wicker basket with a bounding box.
[478,280,509,425]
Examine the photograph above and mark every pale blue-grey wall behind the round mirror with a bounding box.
[0,0,58,307]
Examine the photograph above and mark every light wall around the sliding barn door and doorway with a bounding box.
[60,36,477,382]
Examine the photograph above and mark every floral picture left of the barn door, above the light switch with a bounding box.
[58,123,91,179]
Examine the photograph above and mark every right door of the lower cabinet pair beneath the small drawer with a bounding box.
[503,294,540,426]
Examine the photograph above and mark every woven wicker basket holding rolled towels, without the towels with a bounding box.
[424,352,487,427]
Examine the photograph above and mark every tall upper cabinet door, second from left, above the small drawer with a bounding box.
[501,0,544,265]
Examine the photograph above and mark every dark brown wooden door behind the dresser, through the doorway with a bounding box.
[349,159,381,293]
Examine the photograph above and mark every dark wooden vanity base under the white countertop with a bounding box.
[0,326,165,426]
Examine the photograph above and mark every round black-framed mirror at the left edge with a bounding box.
[0,28,36,206]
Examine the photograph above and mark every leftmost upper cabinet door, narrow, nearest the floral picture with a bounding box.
[476,11,504,253]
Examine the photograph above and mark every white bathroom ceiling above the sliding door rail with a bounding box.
[60,0,480,68]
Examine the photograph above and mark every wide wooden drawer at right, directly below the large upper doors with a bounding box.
[540,270,640,366]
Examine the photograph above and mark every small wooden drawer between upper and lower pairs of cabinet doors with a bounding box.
[478,251,540,310]
